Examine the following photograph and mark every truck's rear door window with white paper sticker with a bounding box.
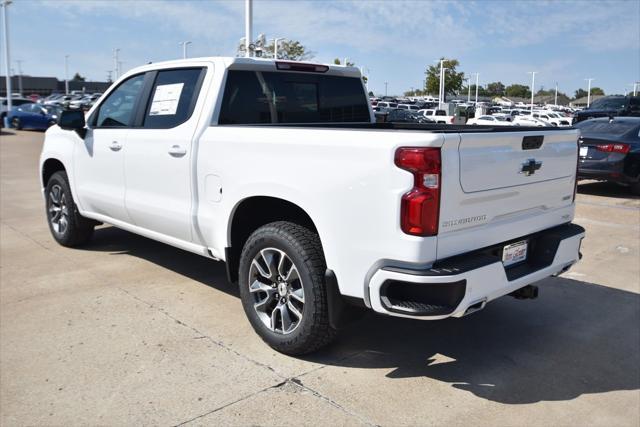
[143,68,204,129]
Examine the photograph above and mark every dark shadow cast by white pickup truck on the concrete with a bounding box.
[85,227,640,404]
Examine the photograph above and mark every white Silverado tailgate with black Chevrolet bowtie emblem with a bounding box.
[438,129,578,259]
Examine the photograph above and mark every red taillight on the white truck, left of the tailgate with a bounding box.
[395,147,441,236]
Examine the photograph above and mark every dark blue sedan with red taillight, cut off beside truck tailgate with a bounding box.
[575,117,640,195]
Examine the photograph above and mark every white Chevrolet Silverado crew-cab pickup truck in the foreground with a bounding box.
[40,58,584,354]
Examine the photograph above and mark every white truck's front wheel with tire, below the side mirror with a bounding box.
[45,171,95,247]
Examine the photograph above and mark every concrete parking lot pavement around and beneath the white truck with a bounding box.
[0,131,640,427]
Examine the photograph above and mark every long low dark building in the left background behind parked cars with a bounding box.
[0,76,111,96]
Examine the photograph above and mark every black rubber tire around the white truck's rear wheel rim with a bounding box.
[238,221,336,356]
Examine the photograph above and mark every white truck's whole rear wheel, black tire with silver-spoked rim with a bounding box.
[239,221,336,355]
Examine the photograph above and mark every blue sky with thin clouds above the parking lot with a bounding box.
[3,0,640,94]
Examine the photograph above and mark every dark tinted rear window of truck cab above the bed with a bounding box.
[219,70,370,124]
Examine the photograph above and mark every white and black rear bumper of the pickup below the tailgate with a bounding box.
[369,224,584,320]
